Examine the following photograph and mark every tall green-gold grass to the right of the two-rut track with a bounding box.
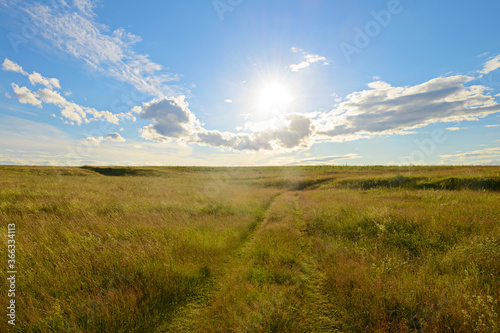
[301,189,500,332]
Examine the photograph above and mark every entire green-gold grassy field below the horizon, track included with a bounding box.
[0,166,500,332]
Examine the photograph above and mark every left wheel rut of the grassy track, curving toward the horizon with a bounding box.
[155,192,283,332]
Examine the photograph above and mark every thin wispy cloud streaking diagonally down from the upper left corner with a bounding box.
[4,0,178,97]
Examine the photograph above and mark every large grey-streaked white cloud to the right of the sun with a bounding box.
[314,75,500,141]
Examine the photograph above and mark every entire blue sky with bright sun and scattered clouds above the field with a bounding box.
[0,0,500,166]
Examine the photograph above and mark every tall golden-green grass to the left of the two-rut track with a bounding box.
[0,169,276,332]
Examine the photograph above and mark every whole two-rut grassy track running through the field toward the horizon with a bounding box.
[160,191,339,332]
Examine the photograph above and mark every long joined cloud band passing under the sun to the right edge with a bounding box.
[136,75,500,151]
